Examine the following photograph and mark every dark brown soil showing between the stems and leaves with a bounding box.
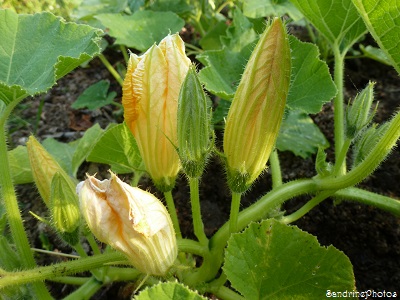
[10,37,400,299]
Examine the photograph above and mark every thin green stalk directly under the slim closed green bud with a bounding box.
[189,178,208,245]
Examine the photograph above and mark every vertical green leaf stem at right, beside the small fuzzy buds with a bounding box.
[333,45,346,175]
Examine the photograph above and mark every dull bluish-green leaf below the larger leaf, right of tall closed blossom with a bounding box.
[276,110,329,158]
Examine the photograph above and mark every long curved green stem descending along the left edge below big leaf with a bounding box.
[0,101,52,299]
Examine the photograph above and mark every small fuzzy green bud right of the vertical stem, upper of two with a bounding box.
[346,82,375,139]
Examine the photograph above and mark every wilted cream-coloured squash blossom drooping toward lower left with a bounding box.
[77,173,178,275]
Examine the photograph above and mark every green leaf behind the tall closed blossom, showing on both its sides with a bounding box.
[196,36,336,113]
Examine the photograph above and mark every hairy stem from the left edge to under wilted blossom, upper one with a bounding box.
[0,252,126,290]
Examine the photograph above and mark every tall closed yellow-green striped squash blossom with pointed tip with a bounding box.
[224,18,291,193]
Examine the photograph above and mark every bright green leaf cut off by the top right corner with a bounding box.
[352,0,400,74]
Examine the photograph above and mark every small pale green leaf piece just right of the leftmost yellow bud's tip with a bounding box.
[42,138,78,176]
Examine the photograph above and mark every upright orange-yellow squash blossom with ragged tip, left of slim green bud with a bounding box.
[122,34,190,192]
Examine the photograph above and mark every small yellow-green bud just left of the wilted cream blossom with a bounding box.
[49,172,81,246]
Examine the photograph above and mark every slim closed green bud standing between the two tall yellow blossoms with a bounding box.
[178,65,212,178]
